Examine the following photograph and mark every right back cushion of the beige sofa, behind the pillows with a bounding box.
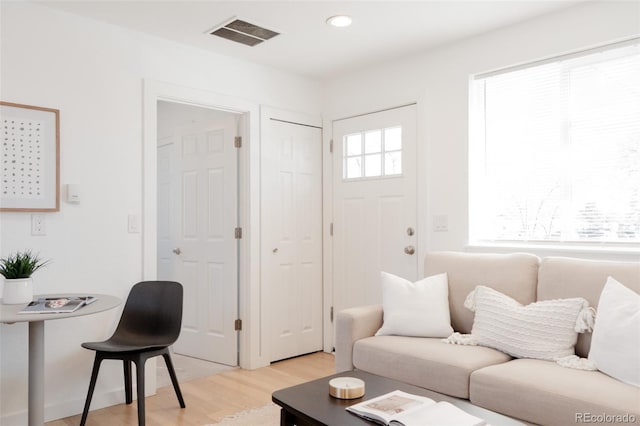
[540,257,640,358]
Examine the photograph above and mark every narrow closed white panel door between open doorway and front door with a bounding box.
[261,120,322,361]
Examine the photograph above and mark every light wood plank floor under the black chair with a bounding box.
[45,352,335,426]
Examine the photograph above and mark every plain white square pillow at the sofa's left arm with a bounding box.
[376,272,453,337]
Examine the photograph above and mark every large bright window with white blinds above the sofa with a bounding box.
[469,40,640,243]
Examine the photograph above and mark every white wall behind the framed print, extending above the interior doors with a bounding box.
[0,2,320,425]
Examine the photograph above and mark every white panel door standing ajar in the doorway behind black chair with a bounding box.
[158,108,239,365]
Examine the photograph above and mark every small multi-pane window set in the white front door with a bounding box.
[342,126,402,180]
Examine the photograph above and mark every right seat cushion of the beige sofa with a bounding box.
[469,359,640,425]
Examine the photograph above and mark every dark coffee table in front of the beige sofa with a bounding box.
[271,371,523,426]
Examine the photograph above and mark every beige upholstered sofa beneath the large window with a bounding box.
[336,252,640,425]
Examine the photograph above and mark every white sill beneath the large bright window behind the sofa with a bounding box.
[465,241,640,262]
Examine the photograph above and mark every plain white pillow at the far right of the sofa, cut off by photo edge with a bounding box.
[589,277,640,387]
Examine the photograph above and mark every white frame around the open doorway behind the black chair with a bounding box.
[141,79,268,369]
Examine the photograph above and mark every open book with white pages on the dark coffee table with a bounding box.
[346,390,487,426]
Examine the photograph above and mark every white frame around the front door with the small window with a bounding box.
[322,101,428,352]
